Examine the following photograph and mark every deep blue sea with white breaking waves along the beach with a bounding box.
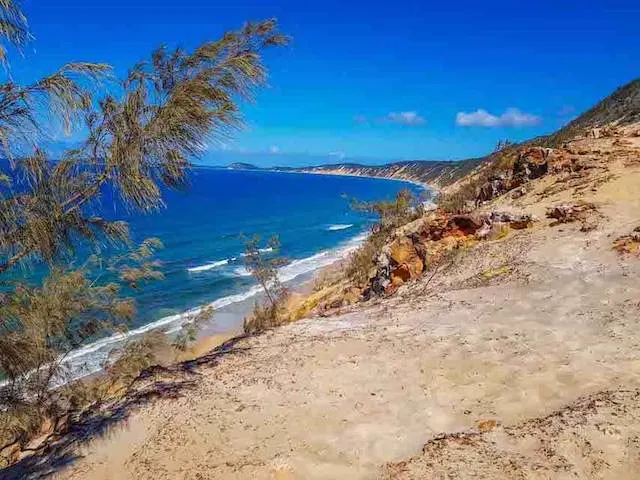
[62,168,420,372]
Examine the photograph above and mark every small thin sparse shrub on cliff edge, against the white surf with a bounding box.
[244,235,288,333]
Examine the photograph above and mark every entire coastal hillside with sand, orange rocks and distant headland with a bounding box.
[0,78,640,480]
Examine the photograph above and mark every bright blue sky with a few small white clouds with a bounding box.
[10,0,640,166]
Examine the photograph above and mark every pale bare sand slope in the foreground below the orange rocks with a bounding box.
[6,131,640,480]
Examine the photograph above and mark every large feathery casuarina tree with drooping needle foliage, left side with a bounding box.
[0,0,287,458]
